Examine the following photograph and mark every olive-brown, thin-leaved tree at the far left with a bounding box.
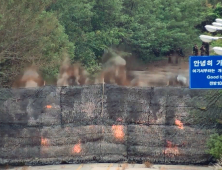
[0,0,74,85]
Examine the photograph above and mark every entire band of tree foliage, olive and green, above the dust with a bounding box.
[0,0,220,83]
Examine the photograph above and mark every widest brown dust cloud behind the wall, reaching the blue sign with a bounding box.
[95,48,189,87]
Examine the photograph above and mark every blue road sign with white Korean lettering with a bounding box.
[189,56,222,89]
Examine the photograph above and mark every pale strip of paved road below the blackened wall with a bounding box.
[3,163,219,170]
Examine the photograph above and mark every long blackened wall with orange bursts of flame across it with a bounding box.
[0,85,215,165]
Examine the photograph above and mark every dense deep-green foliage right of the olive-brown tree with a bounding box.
[50,0,206,66]
